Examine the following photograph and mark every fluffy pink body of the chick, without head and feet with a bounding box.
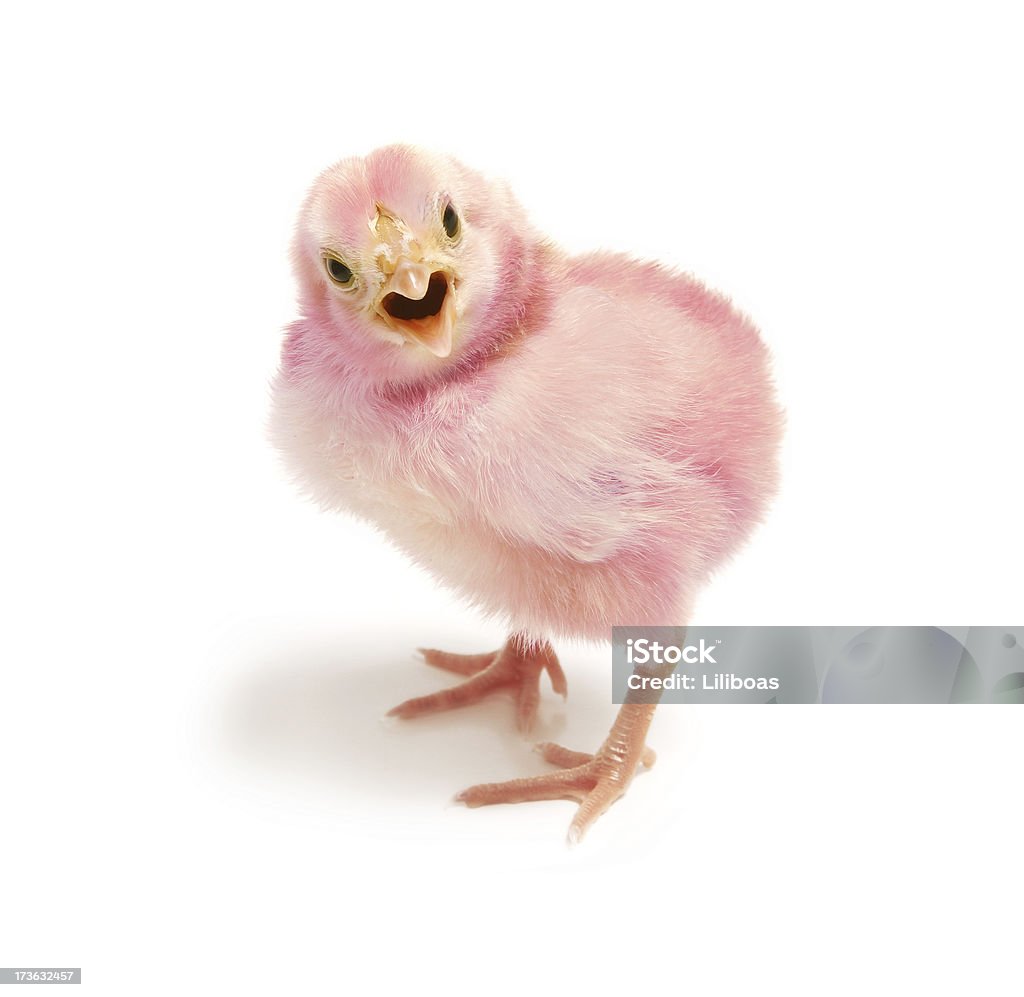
[273,149,781,640]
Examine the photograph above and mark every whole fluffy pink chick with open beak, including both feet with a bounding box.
[271,145,782,840]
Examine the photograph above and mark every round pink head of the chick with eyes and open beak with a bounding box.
[293,145,536,382]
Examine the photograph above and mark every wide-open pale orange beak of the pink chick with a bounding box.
[375,258,455,358]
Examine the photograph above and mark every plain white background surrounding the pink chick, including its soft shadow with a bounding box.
[0,2,1024,995]
